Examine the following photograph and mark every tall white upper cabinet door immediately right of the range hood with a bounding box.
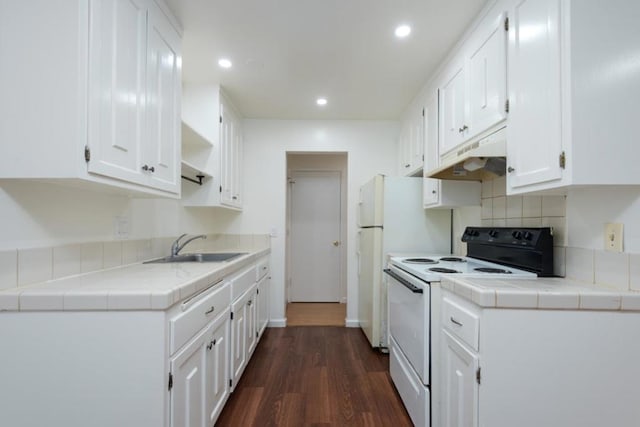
[507,0,562,189]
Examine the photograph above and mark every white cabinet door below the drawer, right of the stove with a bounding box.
[441,330,478,427]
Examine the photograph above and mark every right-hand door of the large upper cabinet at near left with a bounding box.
[144,4,181,192]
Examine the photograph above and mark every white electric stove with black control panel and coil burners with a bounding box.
[385,227,553,427]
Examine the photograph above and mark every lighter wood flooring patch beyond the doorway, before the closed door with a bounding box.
[287,302,347,326]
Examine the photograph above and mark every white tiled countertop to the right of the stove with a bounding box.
[441,277,640,311]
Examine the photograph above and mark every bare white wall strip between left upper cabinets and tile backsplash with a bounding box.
[0,180,224,250]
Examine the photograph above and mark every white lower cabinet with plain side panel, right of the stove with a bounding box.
[442,290,640,427]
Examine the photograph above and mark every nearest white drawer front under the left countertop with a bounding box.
[169,283,231,354]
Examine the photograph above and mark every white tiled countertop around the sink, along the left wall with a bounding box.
[0,248,270,311]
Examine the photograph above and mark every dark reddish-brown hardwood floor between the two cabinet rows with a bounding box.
[216,326,412,427]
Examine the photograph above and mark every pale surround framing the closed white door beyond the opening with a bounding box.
[285,152,348,305]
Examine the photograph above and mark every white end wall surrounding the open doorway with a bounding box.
[235,120,398,323]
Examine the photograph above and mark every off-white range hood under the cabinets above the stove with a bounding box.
[425,127,507,180]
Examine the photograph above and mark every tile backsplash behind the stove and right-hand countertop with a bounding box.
[454,177,640,291]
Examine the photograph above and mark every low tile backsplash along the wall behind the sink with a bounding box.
[0,234,271,291]
